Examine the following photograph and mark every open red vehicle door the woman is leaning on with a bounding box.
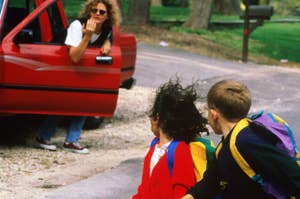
[0,0,121,116]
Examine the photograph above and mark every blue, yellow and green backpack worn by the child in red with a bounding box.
[150,137,215,182]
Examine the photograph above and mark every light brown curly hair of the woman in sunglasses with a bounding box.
[80,0,120,26]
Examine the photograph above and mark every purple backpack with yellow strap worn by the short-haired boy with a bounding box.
[216,111,300,199]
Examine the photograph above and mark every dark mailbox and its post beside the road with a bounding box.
[242,0,273,62]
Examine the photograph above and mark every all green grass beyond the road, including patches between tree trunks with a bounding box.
[151,6,300,62]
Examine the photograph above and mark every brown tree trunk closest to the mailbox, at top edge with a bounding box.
[214,0,241,15]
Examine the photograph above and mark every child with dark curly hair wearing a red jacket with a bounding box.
[132,78,207,199]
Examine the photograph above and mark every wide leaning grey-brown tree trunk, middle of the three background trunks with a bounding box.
[184,0,213,29]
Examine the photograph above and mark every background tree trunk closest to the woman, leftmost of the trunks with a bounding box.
[126,0,150,24]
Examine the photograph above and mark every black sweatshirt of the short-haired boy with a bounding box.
[188,124,300,199]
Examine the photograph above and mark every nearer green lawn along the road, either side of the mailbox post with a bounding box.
[171,23,300,62]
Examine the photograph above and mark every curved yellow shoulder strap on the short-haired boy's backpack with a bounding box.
[229,118,256,181]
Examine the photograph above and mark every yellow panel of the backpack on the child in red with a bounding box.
[189,142,207,182]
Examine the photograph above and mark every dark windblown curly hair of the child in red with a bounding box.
[149,77,208,143]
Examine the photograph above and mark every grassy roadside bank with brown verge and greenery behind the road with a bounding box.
[65,0,300,67]
